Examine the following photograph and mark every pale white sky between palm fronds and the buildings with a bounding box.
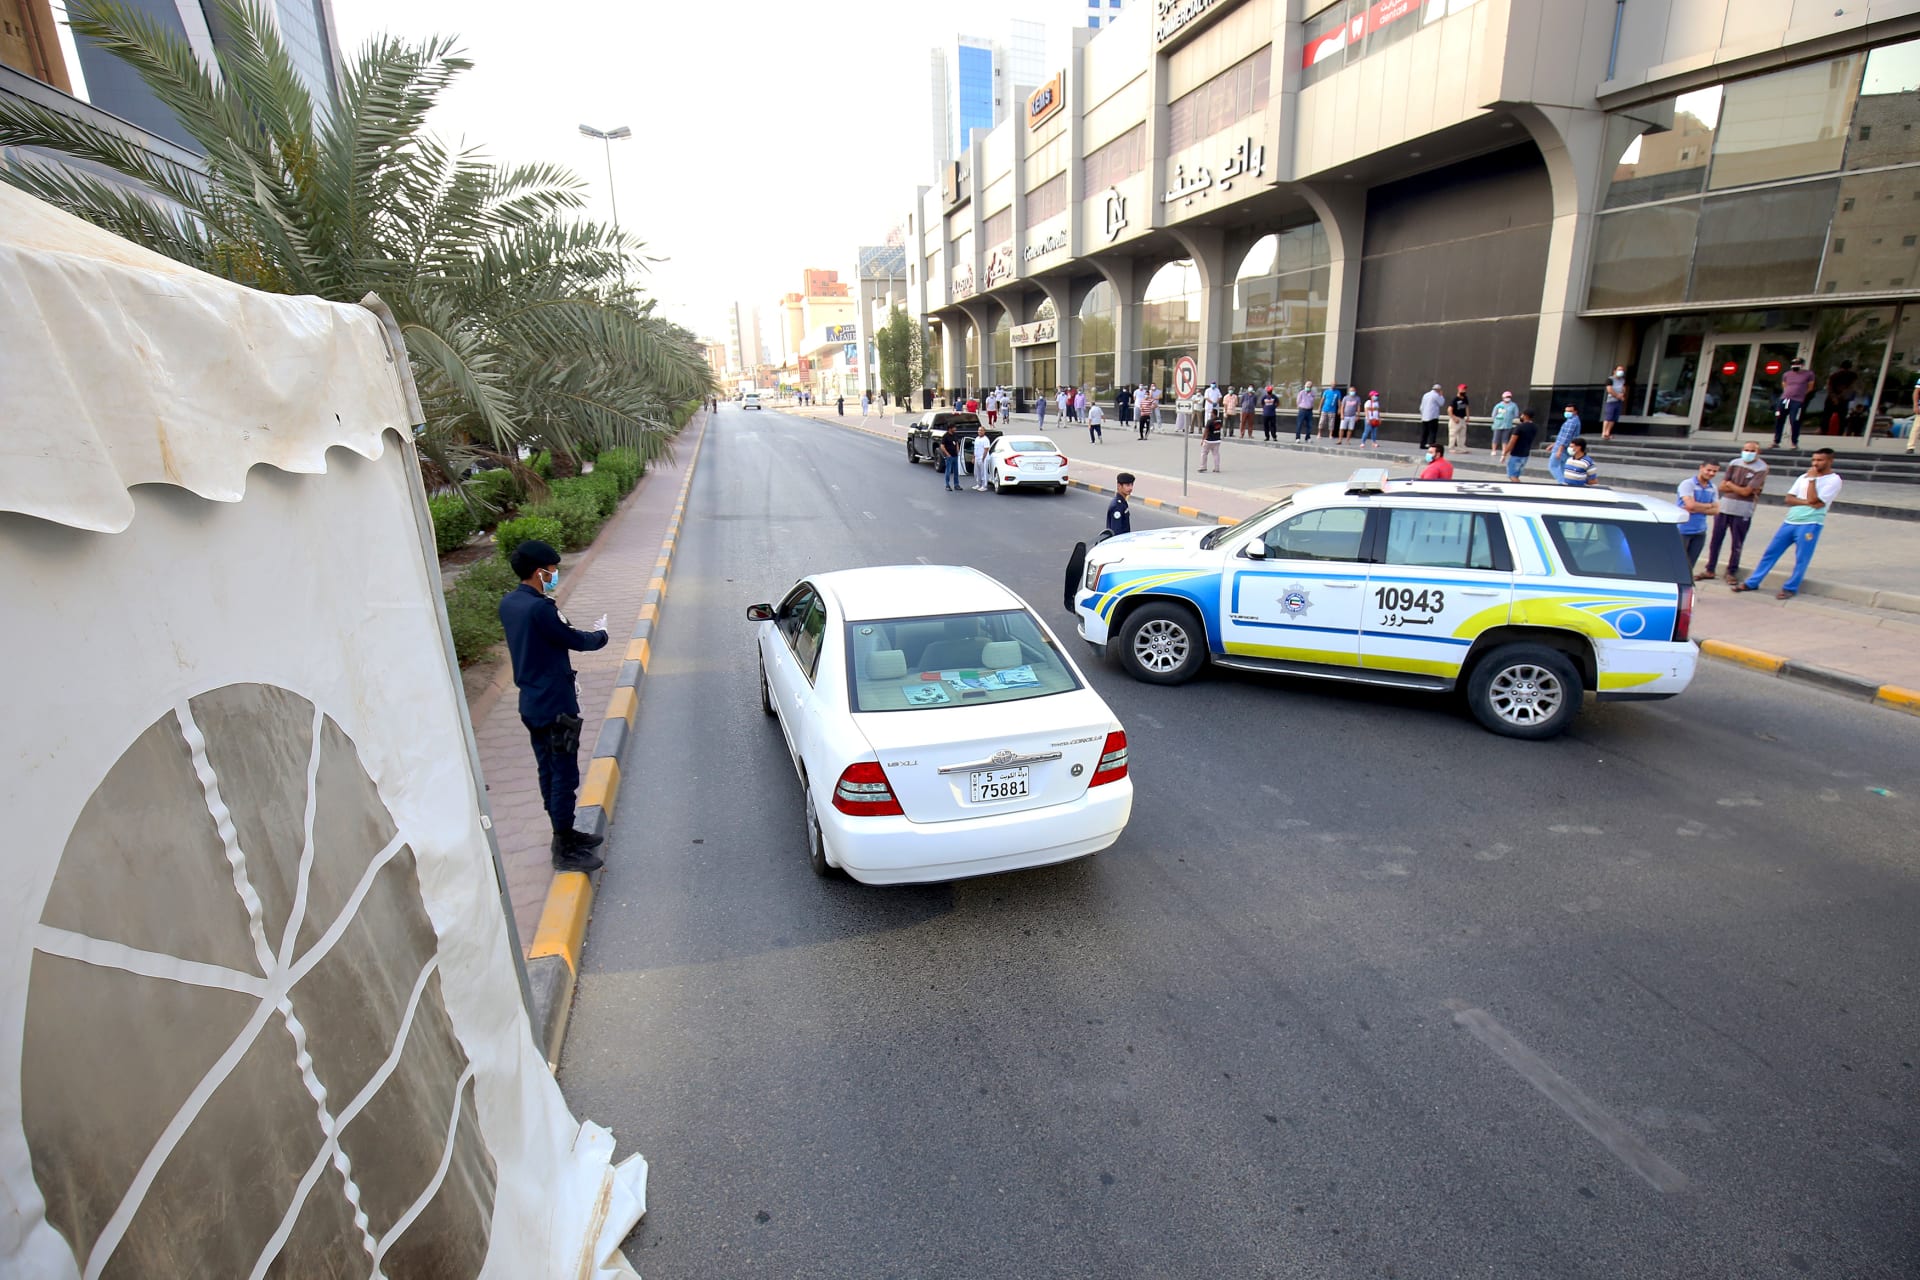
[334,0,1071,338]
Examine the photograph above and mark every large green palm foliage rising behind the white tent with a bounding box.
[0,0,712,476]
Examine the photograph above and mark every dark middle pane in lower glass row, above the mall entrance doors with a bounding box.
[1689,180,1839,301]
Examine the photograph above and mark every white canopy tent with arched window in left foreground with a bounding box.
[0,186,645,1280]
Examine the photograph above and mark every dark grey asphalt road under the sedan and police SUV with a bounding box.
[561,409,1920,1280]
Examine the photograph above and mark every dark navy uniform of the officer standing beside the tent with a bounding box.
[499,581,607,837]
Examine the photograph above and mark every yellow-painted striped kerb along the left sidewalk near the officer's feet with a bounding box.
[526,418,712,1071]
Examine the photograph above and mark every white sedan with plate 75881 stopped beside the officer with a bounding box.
[747,564,1133,885]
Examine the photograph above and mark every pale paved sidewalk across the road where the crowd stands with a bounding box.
[797,407,1920,689]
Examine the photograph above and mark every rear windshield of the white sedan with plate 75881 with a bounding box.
[847,608,1081,712]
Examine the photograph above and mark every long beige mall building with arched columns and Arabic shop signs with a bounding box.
[906,0,1920,436]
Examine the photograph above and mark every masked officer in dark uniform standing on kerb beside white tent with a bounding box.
[499,541,607,871]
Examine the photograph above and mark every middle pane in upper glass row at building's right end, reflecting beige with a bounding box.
[1707,54,1860,190]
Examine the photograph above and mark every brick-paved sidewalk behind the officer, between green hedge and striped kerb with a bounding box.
[470,411,707,948]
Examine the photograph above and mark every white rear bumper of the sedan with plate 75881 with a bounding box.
[820,777,1133,885]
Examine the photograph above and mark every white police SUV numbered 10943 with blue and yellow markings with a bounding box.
[1068,470,1699,739]
